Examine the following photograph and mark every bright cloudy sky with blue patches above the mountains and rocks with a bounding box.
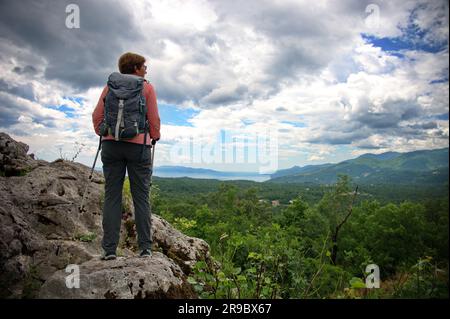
[0,0,449,173]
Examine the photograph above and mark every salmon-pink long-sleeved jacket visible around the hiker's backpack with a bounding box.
[92,82,161,145]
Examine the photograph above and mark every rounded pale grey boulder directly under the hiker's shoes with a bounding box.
[39,252,196,299]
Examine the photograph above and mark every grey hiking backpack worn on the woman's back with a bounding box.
[100,72,149,143]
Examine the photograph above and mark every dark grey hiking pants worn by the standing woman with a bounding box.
[101,141,152,253]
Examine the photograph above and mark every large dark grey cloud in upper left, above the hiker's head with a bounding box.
[0,0,139,90]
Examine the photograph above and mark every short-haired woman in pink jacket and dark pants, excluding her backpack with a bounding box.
[92,52,160,260]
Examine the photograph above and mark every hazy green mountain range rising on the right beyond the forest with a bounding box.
[268,148,449,185]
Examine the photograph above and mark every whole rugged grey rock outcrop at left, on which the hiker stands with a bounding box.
[0,133,209,298]
